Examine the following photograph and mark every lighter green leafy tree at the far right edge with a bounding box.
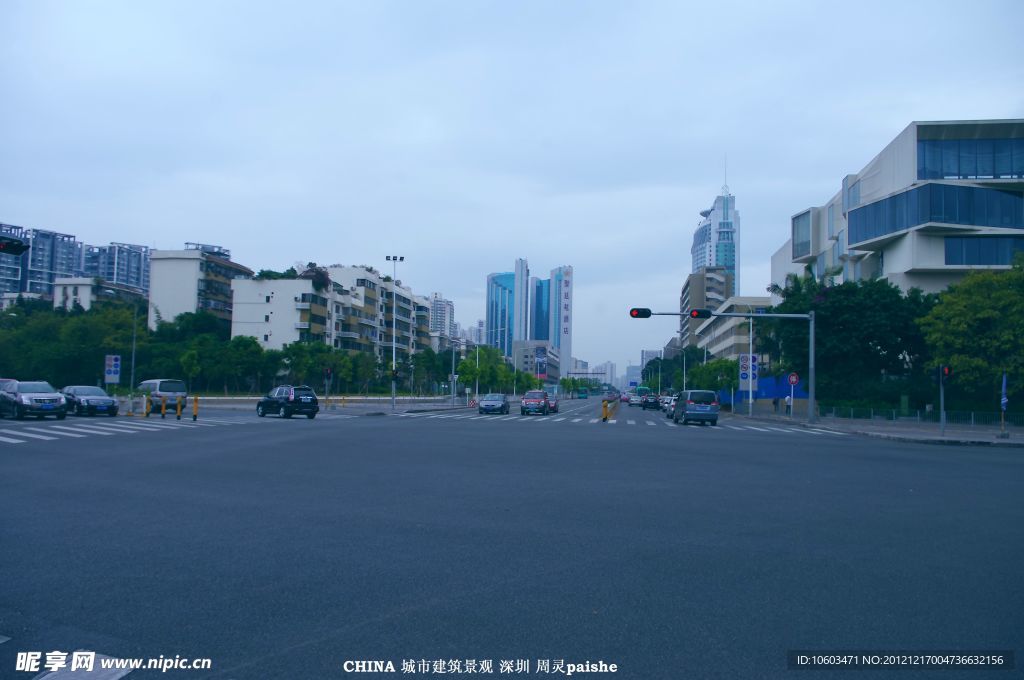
[920,254,1024,410]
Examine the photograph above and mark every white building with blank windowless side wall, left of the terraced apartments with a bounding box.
[148,243,253,329]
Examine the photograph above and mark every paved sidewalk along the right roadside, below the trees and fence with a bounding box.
[734,410,1024,448]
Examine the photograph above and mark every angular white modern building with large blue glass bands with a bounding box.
[772,119,1024,292]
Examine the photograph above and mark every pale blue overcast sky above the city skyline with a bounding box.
[0,0,1024,375]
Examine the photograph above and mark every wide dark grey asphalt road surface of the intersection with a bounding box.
[0,400,1024,680]
